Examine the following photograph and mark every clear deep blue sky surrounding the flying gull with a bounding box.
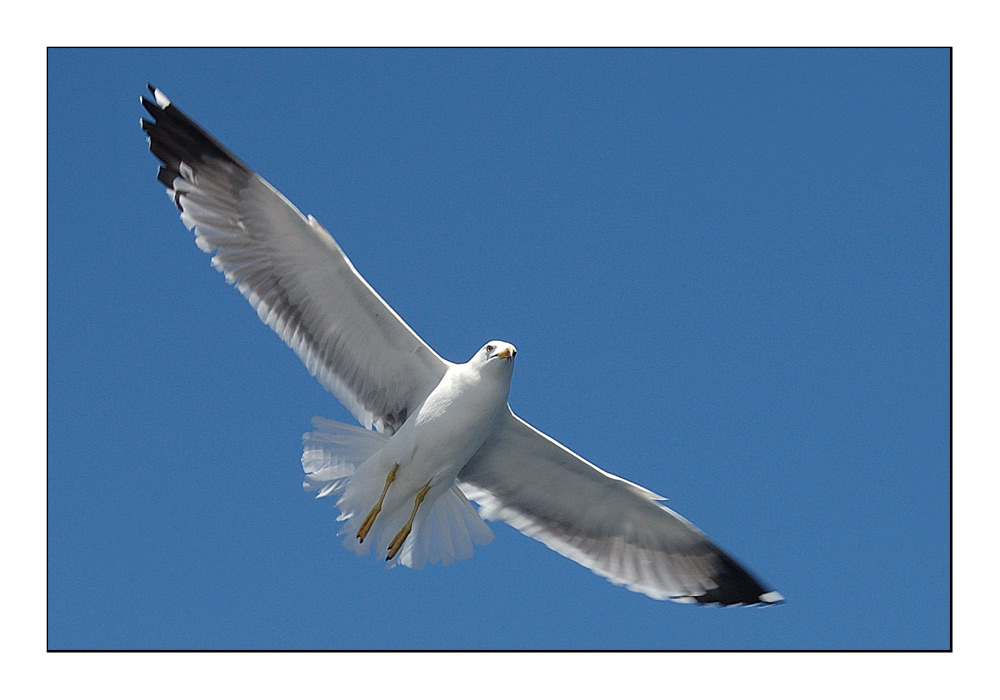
[48,50,951,649]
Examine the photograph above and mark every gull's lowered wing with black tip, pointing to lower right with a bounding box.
[458,413,783,605]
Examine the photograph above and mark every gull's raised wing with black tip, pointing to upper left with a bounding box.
[141,86,448,434]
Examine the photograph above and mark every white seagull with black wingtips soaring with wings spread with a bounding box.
[140,85,783,606]
